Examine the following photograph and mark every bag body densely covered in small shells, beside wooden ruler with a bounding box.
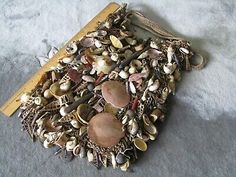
[19,4,193,171]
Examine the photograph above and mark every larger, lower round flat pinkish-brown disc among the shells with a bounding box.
[88,113,124,147]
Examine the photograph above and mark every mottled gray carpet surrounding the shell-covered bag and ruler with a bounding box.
[0,0,236,177]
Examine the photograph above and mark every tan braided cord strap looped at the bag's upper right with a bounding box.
[128,11,206,70]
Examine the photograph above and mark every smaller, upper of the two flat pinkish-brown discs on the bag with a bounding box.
[102,81,130,108]
